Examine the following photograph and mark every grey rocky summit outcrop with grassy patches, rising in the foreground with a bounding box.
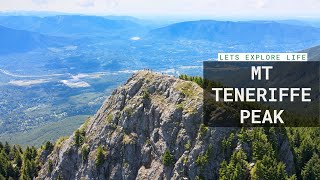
[38,71,290,180]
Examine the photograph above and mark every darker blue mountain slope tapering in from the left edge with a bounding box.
[0,26,57,54]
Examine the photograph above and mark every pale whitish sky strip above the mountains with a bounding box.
[0,0,320,18]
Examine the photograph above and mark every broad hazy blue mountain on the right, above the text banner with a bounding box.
[150,20,320,43]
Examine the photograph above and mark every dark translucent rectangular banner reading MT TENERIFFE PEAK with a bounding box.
[203,61,320,127]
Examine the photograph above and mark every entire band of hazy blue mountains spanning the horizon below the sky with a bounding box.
[0,15,320,54]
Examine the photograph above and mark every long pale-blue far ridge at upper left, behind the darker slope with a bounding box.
[0,15,140,35]
